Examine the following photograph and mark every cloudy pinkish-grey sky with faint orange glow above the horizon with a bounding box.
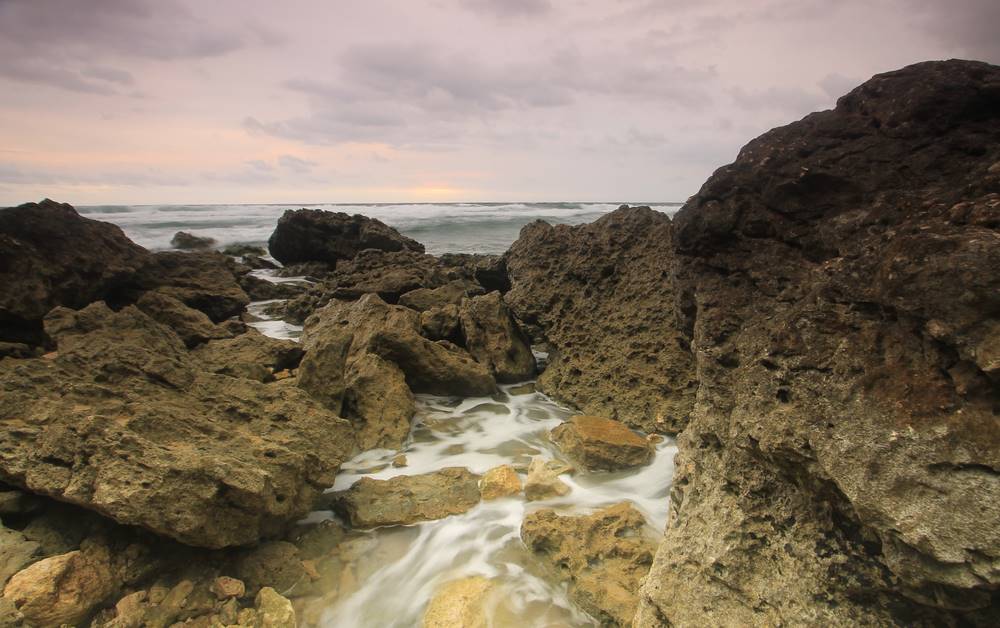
[0,0,1000,206]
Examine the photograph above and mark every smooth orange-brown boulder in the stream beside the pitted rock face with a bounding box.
[549,415,653,471]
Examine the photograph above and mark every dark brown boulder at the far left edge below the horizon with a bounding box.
[0,199,149,344]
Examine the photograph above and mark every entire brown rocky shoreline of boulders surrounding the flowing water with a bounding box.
[0,61,1000,627]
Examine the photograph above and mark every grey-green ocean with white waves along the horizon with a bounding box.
[77,202,681,254]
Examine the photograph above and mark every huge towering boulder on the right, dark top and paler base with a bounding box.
[636,61,1000,626]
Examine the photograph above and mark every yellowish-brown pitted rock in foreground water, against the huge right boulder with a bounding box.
[521,502,655,626]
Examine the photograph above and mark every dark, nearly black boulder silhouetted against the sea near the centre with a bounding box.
[267,209,424,265]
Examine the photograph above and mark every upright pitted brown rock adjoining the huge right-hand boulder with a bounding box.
[504,207,695,432]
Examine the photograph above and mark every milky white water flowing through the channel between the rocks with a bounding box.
[249,277,676,628]
